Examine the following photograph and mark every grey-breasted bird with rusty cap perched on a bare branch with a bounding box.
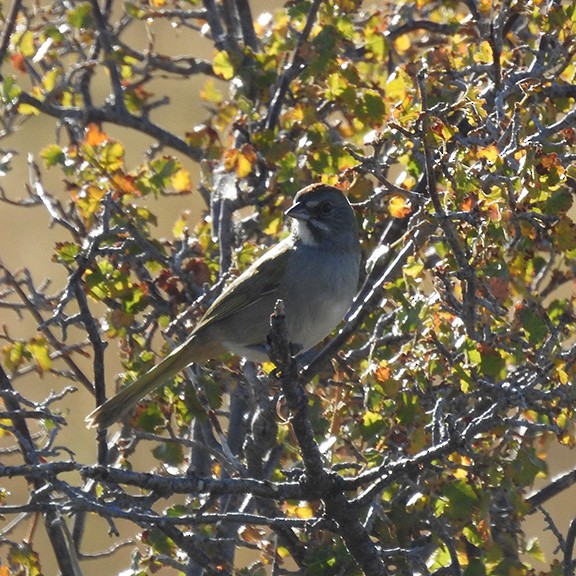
[86,183,361,427]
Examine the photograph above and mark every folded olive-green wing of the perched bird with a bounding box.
[195,238,293,331]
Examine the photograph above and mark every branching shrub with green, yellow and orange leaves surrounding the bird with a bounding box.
[0,0,576,576]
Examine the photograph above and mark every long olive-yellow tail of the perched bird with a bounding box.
[86,338,196,428]
